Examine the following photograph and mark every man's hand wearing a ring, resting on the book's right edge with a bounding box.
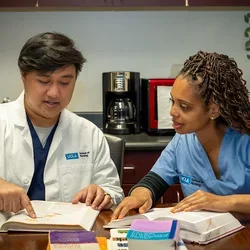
[72,184,113,210]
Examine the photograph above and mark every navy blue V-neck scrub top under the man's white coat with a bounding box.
[27,116,59,200]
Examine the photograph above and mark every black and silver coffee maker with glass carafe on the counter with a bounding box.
[102,71,140,135]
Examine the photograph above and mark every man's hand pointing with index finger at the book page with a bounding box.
[0,180,36,218]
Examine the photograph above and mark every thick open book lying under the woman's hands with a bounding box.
[104,207,244,244]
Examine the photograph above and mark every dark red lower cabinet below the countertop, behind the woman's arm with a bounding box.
[122,150,183,203]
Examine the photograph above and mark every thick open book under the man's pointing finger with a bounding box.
[0,201,99,232]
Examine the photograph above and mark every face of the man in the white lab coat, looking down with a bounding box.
[22,65,76,127]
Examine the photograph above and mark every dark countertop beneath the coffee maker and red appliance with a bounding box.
[115,133,173,151]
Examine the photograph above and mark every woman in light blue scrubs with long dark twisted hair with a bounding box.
[113,51,250,219]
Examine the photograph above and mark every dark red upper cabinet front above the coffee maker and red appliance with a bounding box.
[113,0,185,7]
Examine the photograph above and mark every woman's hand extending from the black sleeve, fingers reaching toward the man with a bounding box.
[111,187,153,220]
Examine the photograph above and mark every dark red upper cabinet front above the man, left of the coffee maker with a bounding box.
[38,0,112,7]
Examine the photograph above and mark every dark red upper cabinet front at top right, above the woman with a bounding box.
[188,0,250,6]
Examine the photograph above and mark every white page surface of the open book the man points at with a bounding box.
[5,201,99,230]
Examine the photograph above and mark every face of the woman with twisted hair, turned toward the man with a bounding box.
[170,75,212,134]
